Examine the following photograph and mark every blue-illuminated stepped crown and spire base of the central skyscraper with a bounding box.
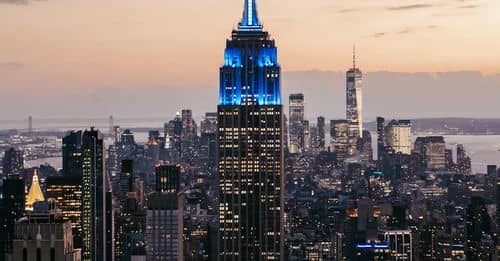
[219,0,281,105]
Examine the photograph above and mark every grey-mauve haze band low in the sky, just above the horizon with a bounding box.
[0,71,500,120]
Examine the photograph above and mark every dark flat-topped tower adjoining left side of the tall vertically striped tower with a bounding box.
[62,131,82,177]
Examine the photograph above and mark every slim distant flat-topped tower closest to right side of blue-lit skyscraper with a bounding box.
[288,93,306,153]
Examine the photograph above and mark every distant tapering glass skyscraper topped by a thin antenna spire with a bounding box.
[346,48,363,138]
